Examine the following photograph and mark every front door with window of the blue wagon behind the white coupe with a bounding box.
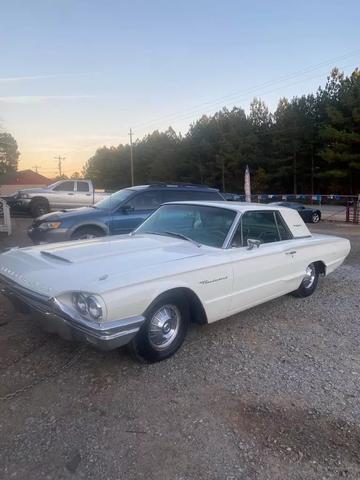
[110,190,162,235]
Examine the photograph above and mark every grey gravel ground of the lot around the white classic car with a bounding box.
[0,219,360,480]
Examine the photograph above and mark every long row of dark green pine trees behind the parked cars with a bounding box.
[83,68,360,194]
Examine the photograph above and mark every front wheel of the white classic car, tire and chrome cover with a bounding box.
[129,295,190,363]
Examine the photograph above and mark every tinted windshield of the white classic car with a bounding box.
[135,205,236,248]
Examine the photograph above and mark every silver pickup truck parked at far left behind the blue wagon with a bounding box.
[6,180,108,217]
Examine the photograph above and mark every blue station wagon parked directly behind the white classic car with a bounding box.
[28,183,223,243]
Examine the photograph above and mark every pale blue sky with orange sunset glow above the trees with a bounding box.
[0,0,360,178]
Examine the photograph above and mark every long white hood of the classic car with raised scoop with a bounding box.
[0,235,207,297]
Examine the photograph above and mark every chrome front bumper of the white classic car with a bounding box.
[0,276,145,350]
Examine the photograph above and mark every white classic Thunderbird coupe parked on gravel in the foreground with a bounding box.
[0,202,350,361]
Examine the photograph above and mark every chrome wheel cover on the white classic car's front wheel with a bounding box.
[148,305,181,350]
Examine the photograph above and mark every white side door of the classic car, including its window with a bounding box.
[230,210,294,313]
